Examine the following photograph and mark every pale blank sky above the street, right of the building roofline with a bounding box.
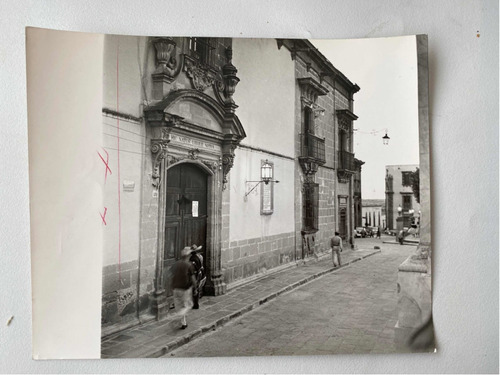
[311,36,419,199]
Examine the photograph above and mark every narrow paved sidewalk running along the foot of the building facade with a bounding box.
[101,249,380,358]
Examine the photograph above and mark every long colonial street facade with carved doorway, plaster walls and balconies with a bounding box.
[99,36,362,335]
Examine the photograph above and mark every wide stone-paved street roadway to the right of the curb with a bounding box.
[165,239,415,357]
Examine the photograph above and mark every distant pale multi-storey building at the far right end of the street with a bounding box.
[385,164,420,230]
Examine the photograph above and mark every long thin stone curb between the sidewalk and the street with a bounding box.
[145,249,381,358]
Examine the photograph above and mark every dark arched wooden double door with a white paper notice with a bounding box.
[163,163,208,290]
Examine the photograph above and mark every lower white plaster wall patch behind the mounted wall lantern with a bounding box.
[229,148,295,241]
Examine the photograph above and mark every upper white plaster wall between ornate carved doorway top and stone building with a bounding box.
[233,38,295,157]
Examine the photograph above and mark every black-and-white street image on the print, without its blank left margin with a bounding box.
[94,35,435,358]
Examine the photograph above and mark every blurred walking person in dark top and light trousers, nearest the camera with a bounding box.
[172,246,196,329]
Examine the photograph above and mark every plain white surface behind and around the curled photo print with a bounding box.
[0,0,499,373]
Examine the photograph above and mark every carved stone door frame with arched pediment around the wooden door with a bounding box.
[144,90,246,317]
